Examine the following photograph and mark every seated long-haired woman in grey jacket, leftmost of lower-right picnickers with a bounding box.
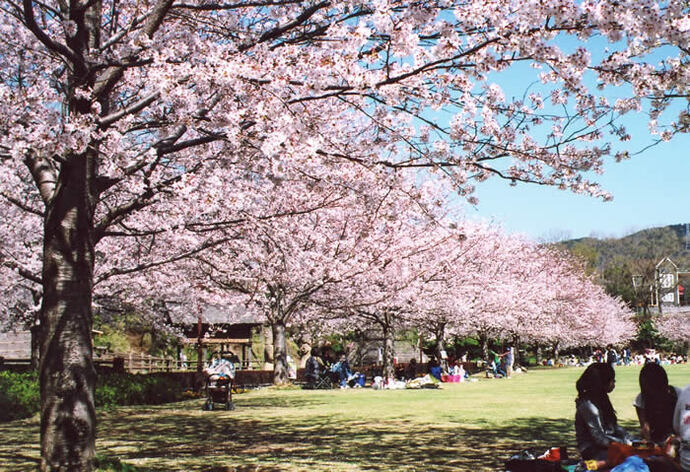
[575,362,631,460]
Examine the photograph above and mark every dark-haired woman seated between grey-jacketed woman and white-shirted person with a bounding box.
[633,362,680,444]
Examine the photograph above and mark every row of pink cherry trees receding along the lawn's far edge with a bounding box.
[150,184,635,383]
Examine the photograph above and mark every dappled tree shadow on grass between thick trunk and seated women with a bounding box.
[92,412,575,472]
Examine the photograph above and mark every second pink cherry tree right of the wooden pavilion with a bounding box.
[314,206,456,378]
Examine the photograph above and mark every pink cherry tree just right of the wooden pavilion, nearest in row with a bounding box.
[187,170,421,384]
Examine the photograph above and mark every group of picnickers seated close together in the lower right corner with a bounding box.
[575,361,690,472]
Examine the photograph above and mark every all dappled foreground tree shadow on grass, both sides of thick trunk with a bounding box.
[0,397,636,472]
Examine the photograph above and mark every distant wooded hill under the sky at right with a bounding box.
[557,224,690,271]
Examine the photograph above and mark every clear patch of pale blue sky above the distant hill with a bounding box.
[466,132,690,240]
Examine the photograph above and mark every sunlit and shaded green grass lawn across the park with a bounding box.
[0,365,690,472]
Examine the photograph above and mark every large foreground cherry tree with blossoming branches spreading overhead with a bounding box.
[0,0,688,470]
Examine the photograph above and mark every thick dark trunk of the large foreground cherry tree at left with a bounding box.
[40,155,96,471]
